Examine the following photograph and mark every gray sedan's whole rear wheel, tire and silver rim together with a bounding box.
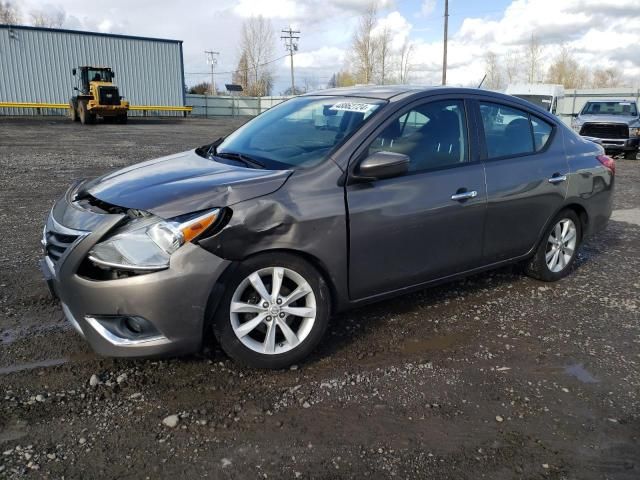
[525,209,582,282]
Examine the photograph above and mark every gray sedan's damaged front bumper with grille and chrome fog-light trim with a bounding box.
[40,188,229,357]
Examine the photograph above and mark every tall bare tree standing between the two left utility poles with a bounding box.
[240,16,275,96]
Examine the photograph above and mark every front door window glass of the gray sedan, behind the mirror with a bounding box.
[369,100,468,172]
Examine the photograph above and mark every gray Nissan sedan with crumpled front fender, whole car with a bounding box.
[42,86,615,368]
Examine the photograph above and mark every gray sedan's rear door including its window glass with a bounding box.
[475,99,569,264]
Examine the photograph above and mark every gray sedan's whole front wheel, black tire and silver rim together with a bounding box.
[213,253,330,369]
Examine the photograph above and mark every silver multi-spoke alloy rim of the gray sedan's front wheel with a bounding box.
[229,267,316,355]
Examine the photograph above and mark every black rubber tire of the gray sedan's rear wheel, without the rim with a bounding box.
[525,209,582,282]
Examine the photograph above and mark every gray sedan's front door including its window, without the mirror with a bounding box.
[346,99,486,300]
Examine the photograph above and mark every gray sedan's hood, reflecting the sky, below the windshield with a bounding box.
[81,150,292,218]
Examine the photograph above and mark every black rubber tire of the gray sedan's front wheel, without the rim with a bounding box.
[213,253,331,369]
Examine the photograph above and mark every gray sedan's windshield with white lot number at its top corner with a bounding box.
[217,96,385,168]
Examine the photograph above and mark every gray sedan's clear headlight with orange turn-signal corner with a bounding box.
[89,209,220,271]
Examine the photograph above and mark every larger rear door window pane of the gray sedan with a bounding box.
[480,102,535,158]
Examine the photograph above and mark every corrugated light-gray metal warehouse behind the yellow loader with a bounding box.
[0,25,185,115]
